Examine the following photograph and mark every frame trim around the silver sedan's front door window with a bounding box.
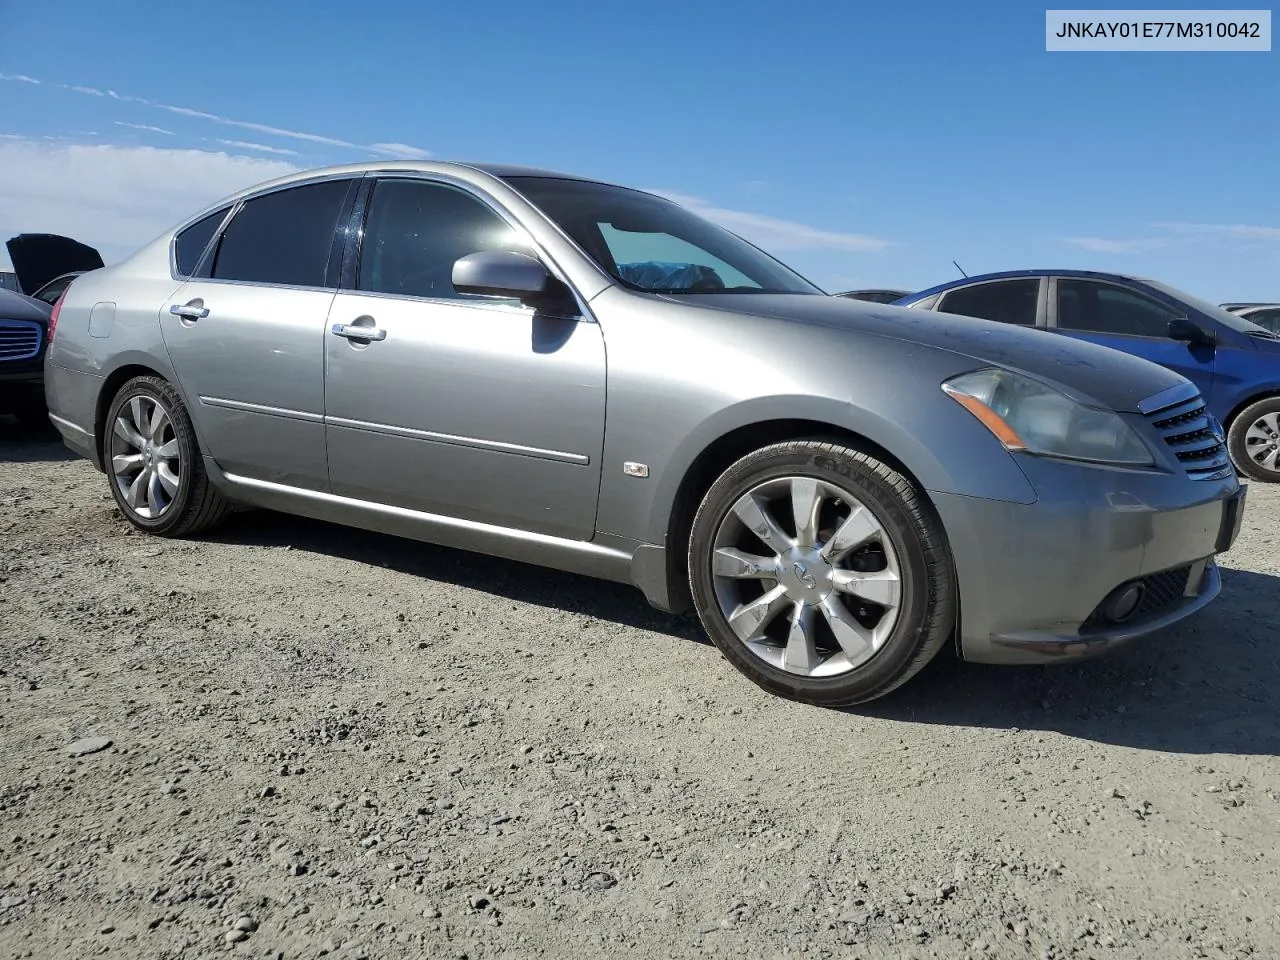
[338,170,598,324]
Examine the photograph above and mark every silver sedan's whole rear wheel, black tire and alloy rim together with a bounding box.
[102,376,232,536]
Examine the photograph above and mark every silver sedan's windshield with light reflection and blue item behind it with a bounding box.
[506,177,822,294]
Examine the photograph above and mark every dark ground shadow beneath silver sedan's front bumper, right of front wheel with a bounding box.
[856,568,1280,755]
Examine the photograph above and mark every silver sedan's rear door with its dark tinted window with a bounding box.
[160,178,358,490]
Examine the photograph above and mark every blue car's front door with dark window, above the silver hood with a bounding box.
[1051,276,1216,398]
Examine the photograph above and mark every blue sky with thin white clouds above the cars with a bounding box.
[0,0,1280,300]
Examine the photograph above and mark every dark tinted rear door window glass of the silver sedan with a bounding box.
[212,180,351,287]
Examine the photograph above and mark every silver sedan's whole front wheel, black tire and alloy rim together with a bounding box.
[689,439,956,707]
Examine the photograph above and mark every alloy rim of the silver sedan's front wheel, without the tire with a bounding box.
[712,476,902,678]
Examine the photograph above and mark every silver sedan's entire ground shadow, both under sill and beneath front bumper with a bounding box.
[209,511,1280,754]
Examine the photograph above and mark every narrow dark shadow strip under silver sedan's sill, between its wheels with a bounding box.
[206,511,710,645]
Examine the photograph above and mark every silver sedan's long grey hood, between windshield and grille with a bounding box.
[667,293,1185,412]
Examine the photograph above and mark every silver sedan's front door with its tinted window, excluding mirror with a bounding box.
[324,178,604,540]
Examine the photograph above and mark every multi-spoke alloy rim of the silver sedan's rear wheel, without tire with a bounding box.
[111,394,182,520]
